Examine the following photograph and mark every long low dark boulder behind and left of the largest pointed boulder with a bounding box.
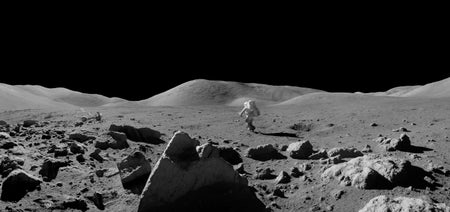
[109,124,164,144]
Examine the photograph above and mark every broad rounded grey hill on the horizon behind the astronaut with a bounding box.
[140,79,322,106]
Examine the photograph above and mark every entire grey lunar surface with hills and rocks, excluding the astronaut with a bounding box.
[0,78,450,212]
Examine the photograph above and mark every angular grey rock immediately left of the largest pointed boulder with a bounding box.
[117,152,152,194]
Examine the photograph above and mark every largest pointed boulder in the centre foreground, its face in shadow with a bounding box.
[138,131,264,212]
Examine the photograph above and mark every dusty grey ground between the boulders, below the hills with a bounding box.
[0,94,450,212]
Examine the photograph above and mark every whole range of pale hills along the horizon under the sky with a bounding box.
[0,77,450,111]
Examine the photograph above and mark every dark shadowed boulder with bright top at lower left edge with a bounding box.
[0,169,42,202]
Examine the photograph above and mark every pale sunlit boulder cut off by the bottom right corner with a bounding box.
[359,195,450,212]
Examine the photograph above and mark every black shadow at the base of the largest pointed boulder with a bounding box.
[152,183,266,212]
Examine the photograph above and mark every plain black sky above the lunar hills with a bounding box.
[0,8,450,100]
